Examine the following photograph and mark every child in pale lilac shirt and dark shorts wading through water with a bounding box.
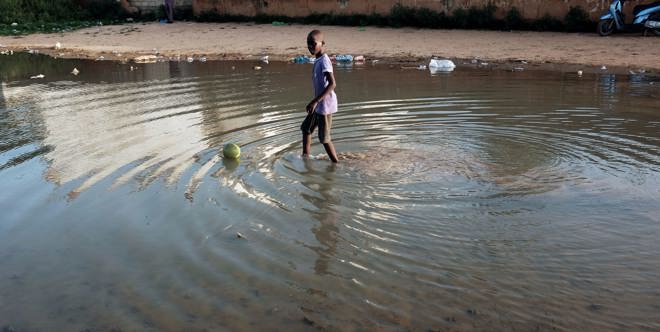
[300,30,338,163]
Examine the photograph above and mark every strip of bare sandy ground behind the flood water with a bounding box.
[0,22,660,72]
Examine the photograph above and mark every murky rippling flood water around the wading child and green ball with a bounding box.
[0,54,660,331]
